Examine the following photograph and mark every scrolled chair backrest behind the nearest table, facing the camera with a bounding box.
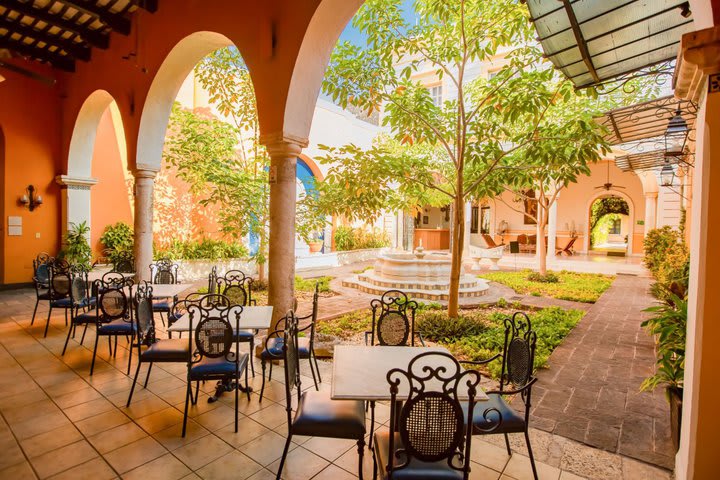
[370,290,417,346]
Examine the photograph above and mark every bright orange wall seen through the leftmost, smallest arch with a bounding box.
[90,108,133,257]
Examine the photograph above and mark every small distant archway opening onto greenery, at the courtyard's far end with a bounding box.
[588,193,633,256]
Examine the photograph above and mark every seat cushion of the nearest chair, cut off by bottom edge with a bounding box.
[374,429,463,480]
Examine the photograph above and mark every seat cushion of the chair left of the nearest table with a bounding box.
[292,390,365,440]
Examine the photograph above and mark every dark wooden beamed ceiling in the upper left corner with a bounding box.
[0,0,158,72]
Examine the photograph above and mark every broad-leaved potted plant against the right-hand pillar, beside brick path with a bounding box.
[641,293,687,391]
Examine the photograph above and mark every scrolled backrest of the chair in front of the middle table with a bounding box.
[187,297,242,363]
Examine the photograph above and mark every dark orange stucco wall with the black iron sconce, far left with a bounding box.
[0,66,61,283]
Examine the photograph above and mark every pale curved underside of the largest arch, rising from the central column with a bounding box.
[283,0,364,143]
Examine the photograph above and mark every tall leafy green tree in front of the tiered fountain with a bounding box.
[321,0,612,317]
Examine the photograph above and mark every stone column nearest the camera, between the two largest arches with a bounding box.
[266,141,302,330]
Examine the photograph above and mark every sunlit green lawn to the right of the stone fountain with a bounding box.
[480,270,615,303]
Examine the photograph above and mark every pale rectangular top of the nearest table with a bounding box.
[331,345,488,402]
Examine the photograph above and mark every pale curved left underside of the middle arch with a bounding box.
[135,31,236,172]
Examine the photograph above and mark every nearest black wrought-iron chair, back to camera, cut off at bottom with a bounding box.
[373,352,486,480]
